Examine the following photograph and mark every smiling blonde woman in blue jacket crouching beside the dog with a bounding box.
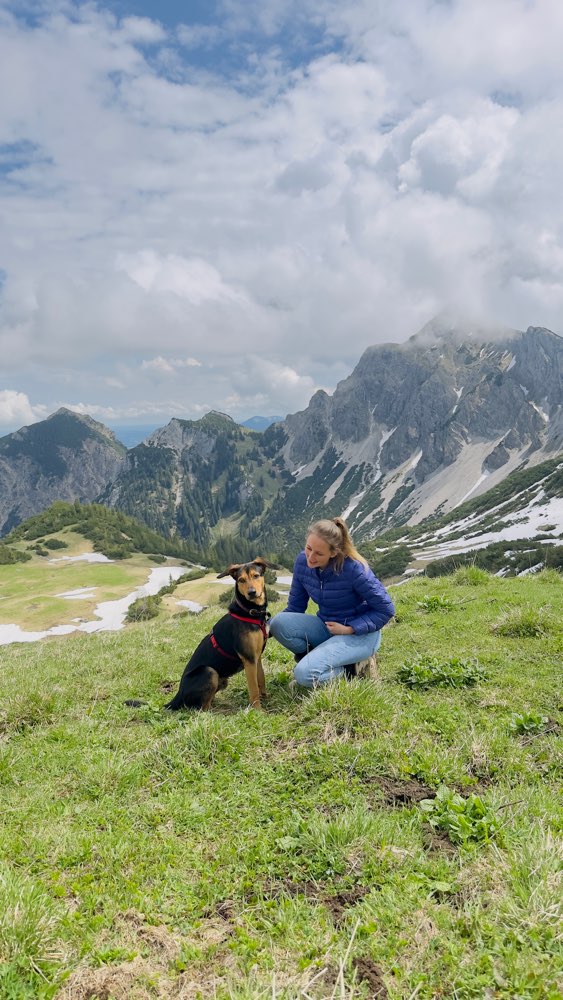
[270,517,395,687]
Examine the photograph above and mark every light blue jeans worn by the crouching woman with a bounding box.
[270,611,381,687]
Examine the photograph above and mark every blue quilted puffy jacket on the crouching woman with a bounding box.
[285,552,395,635]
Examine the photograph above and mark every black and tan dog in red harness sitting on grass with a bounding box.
[164,559,270,710]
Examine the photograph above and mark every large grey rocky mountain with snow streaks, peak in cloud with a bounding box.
[252,319,563,547]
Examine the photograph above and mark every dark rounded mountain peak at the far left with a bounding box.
[0,408,126,534]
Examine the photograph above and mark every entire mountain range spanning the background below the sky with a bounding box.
[0,315,563,561]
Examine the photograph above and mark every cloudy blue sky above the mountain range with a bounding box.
[0,0,563,434]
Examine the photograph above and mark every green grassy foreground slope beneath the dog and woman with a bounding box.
[0,563,563,1000]
